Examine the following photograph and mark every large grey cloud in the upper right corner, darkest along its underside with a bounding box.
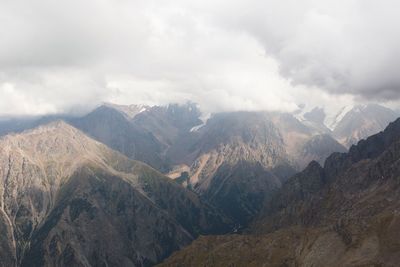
[195,0,400,100]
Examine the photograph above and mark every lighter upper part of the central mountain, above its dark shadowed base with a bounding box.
[167,112,334,188]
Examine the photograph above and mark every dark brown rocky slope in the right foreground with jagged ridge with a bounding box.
[161,120,400,266]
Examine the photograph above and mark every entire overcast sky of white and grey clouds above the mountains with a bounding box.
[0,0,400,115]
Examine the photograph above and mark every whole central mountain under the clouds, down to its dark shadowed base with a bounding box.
[167,112,345,225]
